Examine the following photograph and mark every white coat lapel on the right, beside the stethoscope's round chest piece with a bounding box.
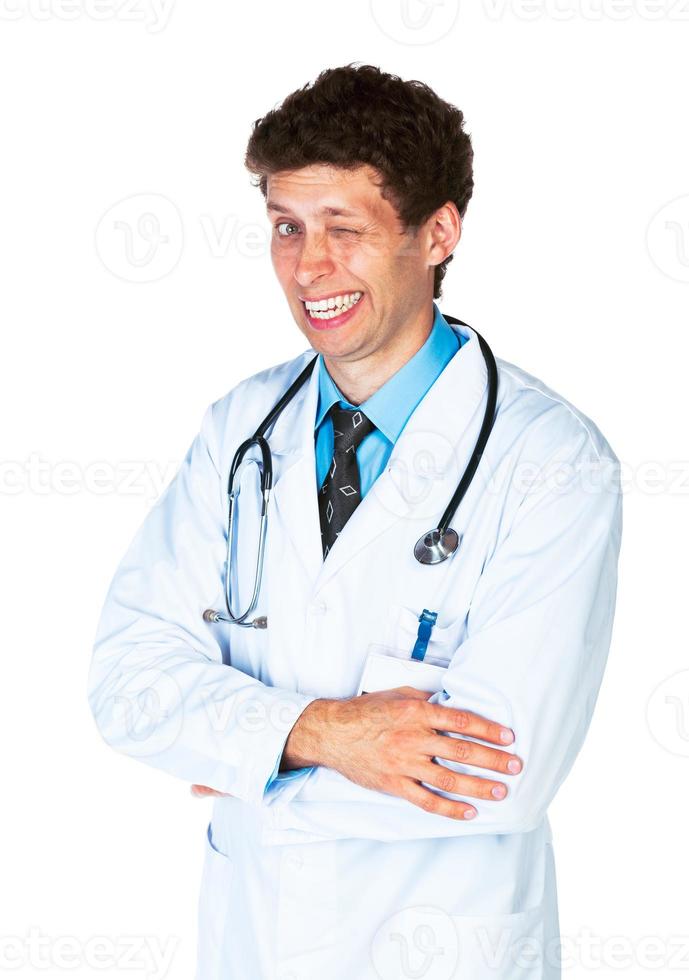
[312,326,487,588]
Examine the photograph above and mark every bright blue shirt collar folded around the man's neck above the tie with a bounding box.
[315,303,461,444]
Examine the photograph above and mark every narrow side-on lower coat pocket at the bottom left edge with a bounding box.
[196,823,234,980]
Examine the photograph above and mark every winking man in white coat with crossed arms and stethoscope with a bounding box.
[89,65,621,980]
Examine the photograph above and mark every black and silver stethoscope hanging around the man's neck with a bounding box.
[203,313,498,629]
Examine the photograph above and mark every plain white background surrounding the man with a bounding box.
[0,0,689,980]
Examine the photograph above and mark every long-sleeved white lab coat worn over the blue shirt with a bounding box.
[89,326,621,980]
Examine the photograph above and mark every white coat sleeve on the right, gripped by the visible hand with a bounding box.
[264,424,622,841]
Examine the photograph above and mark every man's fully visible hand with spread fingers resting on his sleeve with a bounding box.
[282,687,522,820]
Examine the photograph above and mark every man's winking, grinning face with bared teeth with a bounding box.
[266,164,458,362]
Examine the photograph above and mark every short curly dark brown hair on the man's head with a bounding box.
[244,63,474,299]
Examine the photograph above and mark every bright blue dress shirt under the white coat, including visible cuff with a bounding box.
[265,303,464,790]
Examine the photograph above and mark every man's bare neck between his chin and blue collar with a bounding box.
[323,308,434,405]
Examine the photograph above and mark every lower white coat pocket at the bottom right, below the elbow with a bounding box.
[450,905,544,980]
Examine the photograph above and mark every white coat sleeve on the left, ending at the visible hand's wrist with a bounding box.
[88,405,320,802]
